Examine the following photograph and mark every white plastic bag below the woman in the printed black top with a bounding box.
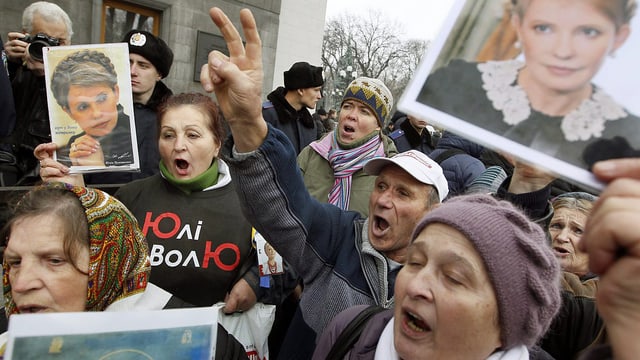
[216,303,276,360]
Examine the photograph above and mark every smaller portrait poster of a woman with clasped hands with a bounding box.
[43,43,140,173]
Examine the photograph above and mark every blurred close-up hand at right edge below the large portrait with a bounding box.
[580,158,640,359]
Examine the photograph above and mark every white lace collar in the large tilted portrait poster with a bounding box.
[478,60,627,141]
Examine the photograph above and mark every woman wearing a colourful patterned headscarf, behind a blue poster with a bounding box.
[0,183,246,359]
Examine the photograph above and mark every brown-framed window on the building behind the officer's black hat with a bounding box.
[100,0,162,43]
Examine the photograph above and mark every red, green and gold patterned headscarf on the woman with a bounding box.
[2,183,151,316]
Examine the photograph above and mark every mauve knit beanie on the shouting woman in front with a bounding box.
[411,194,561,349]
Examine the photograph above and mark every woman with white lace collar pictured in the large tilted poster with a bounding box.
[419,0,640,170]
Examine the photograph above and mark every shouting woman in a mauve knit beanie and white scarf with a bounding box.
[314,195,561,360]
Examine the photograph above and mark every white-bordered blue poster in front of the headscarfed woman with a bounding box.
[5,307,218,360]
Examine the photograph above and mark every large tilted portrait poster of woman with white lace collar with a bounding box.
[398,0,640,192]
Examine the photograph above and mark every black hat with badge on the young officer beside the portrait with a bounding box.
[122,30,173,78]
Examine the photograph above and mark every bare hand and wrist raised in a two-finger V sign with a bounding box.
[200,7,268,152]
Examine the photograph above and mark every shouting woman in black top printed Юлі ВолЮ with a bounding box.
[35,93,293,312]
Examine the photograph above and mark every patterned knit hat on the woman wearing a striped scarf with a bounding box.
[340,77,393,127]
